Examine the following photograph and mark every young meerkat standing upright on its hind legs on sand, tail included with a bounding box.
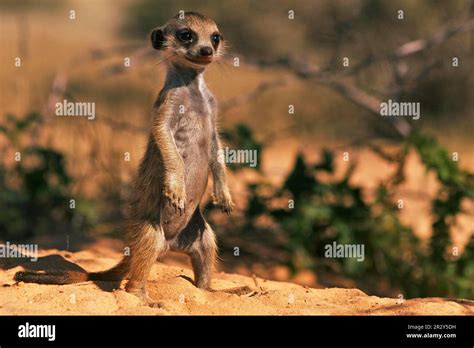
[15,12,234,302]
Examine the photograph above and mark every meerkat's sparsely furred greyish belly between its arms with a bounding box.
[161,114,211,239]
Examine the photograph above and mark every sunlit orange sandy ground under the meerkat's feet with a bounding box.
[0,242,474,315]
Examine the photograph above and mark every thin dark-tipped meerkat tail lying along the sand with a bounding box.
[14,258,128,285]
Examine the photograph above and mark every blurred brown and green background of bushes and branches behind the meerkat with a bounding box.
[0,0,474,298]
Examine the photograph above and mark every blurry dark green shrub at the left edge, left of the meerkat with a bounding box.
[0,113,77,239]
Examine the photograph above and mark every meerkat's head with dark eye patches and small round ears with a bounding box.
[151,12,224,68]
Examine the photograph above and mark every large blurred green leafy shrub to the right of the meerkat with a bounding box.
[218,123,474,297]
